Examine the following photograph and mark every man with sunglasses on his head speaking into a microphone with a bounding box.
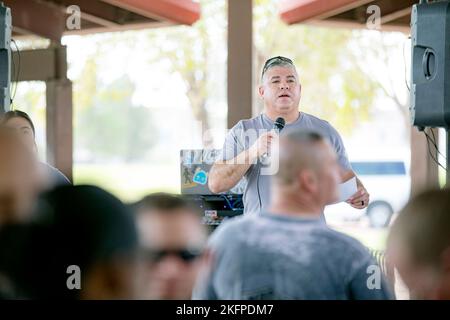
[208,56,369,214]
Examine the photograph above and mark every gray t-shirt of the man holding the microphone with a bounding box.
[221,112,351,213]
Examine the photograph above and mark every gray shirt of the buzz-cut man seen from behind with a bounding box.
[193,213,393,300]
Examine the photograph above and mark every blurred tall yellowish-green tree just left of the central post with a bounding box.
[144,0,226,148]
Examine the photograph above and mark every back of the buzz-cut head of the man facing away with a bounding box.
[274,129,327,186]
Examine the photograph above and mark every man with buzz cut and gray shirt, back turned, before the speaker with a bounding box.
[193,130,392,300]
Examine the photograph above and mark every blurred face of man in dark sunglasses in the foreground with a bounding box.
[134,193,210,300]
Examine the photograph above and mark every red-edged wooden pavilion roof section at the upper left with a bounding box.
[3,0,200,41]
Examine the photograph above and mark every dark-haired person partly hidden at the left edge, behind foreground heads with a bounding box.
[0,110,71,187]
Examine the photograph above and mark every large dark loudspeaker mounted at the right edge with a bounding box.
[410,1,450,128]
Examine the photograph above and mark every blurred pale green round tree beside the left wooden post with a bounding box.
[75,69,157,162]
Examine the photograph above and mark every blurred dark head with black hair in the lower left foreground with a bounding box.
[0,186,137,299]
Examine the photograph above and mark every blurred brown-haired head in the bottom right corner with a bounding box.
[387,189,450,300]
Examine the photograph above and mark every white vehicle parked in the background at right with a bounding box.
[324,154,411,228]
